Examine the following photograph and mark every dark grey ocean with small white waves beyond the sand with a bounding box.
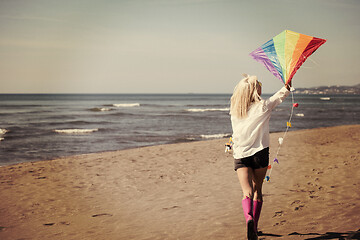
[0,94,360,166]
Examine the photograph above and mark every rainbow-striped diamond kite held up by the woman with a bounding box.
[250,30,326,84]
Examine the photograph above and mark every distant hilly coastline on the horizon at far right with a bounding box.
[295,84,360,95]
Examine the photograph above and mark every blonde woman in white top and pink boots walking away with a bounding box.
[230,74,291,239]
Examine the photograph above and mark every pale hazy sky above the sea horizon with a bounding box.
[0,0,360,93]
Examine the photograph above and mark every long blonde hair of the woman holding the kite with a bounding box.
[230,74,261,118]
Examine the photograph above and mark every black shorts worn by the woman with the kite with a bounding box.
[234,147,269,171]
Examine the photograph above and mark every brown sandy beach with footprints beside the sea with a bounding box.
[0,125,360,239]
